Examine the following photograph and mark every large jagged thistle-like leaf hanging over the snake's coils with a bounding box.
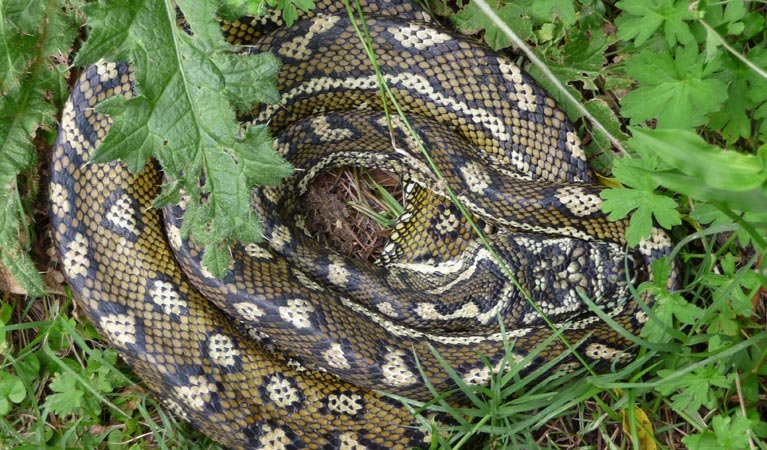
[77,0,292,274]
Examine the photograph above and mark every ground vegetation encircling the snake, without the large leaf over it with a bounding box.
[0,0,767,449]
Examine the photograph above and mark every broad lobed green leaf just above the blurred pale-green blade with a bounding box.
[621,46,727,129]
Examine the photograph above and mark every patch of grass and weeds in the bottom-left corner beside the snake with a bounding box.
[0,299,225,450]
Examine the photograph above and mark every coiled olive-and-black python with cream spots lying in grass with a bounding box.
[50,2,671,449]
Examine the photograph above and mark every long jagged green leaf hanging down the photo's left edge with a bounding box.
[0,0,77,296]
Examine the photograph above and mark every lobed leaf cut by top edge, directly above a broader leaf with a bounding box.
[615,0,695,46]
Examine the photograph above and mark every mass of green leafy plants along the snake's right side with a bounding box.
[432,0,767,449]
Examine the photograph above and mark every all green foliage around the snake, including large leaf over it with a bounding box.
[0,0,767,449]
